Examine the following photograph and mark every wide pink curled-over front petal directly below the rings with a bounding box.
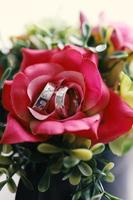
[30,115,101,141]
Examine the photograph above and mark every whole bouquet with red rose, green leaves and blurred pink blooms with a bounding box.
[0,13,133,200]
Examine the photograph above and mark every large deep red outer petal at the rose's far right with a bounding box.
[98,91,133,143]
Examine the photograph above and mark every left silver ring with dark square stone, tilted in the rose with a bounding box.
[33,83,56,111]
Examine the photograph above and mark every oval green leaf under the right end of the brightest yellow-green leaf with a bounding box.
[78,162,92,176]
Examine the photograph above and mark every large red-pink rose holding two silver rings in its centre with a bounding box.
[1,46,133,143]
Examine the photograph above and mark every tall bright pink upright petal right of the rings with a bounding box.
[82,60,109,112]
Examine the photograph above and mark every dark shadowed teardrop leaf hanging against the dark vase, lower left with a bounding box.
[38,169,50,192]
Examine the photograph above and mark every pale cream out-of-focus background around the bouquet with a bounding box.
[0,0,133,200]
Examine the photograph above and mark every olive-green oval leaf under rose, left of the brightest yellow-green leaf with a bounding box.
[37,143,62,154]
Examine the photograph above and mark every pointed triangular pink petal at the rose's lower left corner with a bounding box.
[0,115,46,144]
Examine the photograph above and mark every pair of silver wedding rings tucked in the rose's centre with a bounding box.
[33,82,79,118]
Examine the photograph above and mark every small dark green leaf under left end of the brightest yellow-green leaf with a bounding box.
[63,156,80,168]
